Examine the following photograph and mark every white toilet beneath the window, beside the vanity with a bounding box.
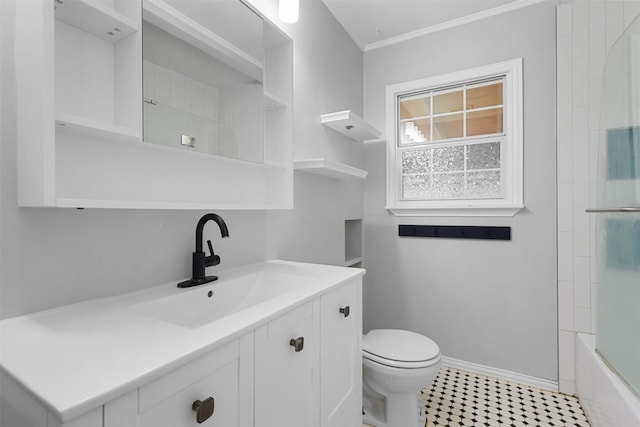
[362,329,441,427]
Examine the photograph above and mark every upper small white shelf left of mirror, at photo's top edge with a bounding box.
[55,0,138,43]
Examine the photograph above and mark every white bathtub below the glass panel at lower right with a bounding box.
[575,333,640,427]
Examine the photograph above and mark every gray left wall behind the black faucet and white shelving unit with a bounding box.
[0,0,362,318]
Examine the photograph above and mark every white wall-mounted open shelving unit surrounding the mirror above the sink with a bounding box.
[16,0,293,210]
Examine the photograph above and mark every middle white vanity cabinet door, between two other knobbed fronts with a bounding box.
[255,303,318,427]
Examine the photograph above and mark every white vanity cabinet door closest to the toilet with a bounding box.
[320,281,362,426]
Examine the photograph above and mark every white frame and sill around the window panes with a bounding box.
[386,58,524,216]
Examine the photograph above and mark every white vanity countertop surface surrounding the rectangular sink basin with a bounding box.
[0,260,364,422]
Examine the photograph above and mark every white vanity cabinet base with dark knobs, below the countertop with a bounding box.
[0,267,362,427]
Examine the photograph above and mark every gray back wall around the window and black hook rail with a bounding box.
[364,2,557,380]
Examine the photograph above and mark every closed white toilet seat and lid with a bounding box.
[362,329,440,369]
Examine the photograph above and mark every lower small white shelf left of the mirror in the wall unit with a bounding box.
[56,112,140,142]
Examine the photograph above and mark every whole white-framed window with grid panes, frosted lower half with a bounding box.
[387,59,523,216]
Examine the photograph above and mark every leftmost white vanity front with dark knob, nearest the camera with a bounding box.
[138,341,240,427]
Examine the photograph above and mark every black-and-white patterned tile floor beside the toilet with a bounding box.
[363,366,589,427]
